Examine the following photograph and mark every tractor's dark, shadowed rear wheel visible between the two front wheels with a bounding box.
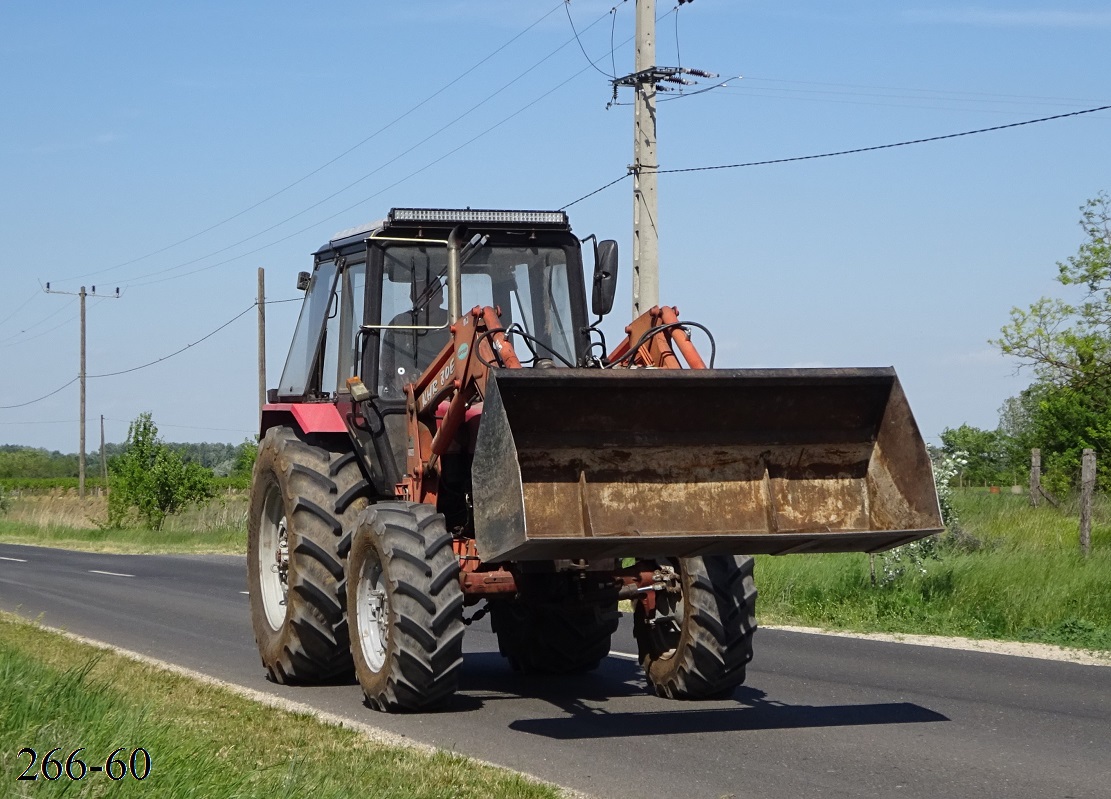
[490,599,620,675]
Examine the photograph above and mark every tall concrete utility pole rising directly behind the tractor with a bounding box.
[632,0,660,319]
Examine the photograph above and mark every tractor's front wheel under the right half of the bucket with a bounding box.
[633,556,757,699]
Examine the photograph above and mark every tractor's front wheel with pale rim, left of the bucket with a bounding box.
[347,501,463,712]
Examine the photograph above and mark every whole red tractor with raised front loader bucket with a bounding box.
[248,208,941,711]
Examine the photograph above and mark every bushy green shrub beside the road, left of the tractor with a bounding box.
[108,413,216,530]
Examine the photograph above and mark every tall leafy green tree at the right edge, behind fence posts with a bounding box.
[992,192,1111,491]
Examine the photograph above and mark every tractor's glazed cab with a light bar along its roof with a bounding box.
[273,208,617,405]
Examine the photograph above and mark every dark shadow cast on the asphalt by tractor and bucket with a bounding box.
[453,653,949,740]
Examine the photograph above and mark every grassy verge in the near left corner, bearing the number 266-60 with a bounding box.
[0,616,560,799]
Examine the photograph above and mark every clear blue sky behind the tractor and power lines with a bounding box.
[0,0,1111,451]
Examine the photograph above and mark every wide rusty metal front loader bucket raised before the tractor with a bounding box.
[472,368,942,562]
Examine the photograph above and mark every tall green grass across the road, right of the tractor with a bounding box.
[757,491,1111,650]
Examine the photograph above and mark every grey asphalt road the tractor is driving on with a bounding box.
[0,545,1111,799]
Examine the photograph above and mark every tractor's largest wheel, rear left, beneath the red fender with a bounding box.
[247,427,368,683]
